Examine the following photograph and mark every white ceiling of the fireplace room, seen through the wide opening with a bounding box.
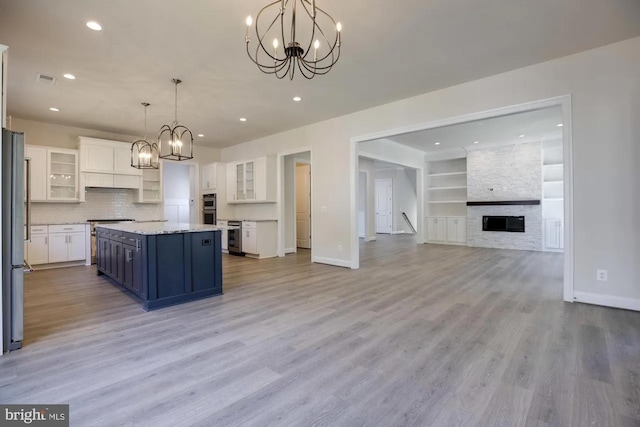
[386,107,563,154]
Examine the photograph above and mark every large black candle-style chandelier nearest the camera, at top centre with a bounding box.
[245,0,342,80]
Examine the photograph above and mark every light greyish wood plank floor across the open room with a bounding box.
[0,236,640,426]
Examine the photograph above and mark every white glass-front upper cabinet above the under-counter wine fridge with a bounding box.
[227,156,276,203]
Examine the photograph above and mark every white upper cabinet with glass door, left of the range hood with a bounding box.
[47,148,78,202]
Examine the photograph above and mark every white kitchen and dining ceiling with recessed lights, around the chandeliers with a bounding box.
[0,0,640,147]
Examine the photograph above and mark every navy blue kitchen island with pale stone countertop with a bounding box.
[96,222,222,310]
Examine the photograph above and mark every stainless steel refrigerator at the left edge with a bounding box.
[2,129,31,351]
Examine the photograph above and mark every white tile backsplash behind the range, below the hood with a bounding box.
[31,188,164,224]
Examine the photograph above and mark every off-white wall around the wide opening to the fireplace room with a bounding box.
[222,38,640,307]
